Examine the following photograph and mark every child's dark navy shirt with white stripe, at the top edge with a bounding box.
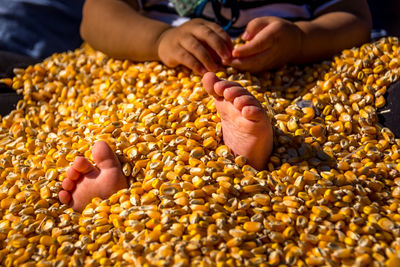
[139,0,345,36]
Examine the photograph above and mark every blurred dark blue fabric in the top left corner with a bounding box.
[0,0,84,59]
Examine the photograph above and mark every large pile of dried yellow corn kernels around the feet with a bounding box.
[0,38,400,266]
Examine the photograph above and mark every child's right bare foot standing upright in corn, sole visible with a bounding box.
[203,72,273,170]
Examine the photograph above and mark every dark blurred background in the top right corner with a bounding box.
[368,0,400,37]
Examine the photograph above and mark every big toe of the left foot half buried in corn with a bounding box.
[92,141,121,169]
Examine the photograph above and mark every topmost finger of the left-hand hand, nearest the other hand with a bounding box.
[193,25,231,61]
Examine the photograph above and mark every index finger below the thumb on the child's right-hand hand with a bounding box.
[232,27,275,57]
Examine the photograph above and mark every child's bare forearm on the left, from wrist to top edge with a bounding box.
[81,0,170,61]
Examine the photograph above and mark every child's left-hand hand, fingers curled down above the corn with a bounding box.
[157,19,232,74]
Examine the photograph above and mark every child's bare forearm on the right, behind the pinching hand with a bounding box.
[292,6,371,63]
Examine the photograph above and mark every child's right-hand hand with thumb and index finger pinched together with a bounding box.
[230,17,303,72]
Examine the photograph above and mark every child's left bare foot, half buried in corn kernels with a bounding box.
[58,141,128,212]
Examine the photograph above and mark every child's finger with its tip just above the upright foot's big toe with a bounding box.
[181,35,218,72]
